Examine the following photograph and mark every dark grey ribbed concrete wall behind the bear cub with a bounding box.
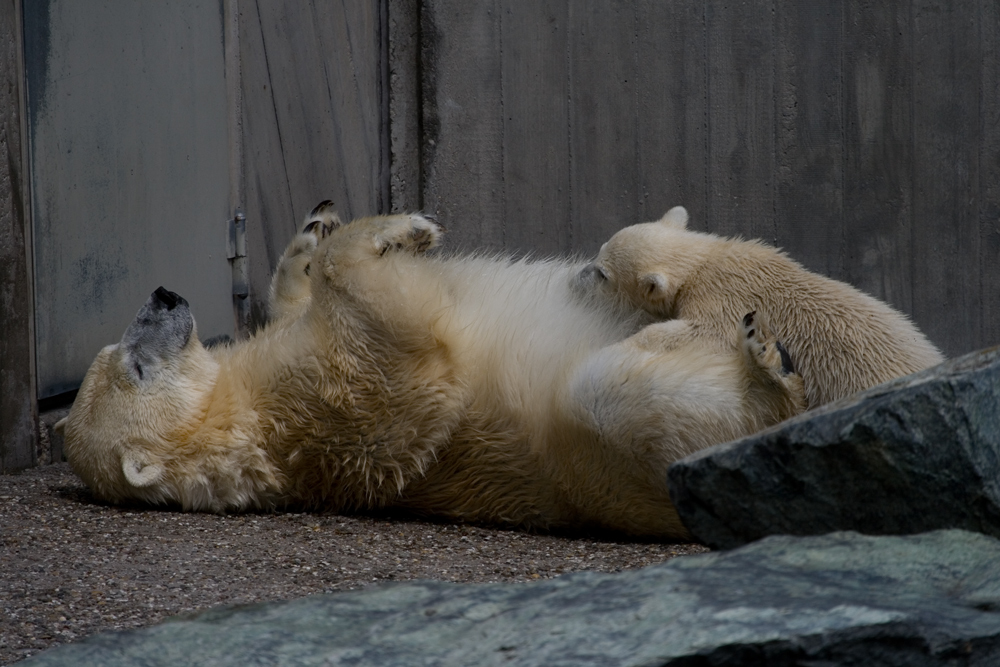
[393,0,1000,355]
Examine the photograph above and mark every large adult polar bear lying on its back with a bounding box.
[60,211,804,539]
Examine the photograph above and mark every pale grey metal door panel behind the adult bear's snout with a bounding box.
[23,0,234,398]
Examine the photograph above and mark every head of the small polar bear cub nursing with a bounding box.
[577,206,706,318]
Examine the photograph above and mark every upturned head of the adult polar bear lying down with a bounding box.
[56,287,218,503]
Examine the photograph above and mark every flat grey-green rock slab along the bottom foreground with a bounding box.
[22,531,1000,667]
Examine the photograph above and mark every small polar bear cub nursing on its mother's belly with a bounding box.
[578,206,944,408]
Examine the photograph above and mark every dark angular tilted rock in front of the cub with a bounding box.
[668,348,1000,549]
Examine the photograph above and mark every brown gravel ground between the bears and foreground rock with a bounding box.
[0,463,706,665]
